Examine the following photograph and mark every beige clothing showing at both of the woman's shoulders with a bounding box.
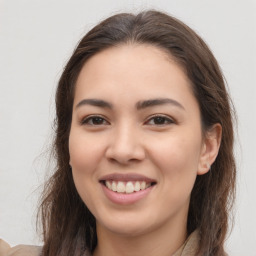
[0,231,199,256]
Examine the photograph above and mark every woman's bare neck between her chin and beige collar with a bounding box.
[93,216,187,256]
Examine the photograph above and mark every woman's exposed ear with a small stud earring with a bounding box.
[197,124,222,175]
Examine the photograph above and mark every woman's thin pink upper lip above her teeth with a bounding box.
[100,173,156,183]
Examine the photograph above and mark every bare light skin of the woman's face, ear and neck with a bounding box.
[69,45,221,256]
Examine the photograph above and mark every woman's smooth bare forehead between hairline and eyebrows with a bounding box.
[75,44,196,107]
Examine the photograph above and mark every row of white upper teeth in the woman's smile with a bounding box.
[105,180,151,194]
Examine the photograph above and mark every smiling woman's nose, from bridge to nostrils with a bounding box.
[106,124,145,165]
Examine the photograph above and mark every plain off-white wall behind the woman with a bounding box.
[0,0,256,256]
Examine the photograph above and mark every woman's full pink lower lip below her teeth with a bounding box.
[101,184,154,205]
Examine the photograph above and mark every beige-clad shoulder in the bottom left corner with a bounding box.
[0,239,42,256]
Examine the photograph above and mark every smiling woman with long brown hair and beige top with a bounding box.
[0,11,236,256]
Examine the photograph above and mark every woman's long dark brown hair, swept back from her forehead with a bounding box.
[39,11,236,256]
